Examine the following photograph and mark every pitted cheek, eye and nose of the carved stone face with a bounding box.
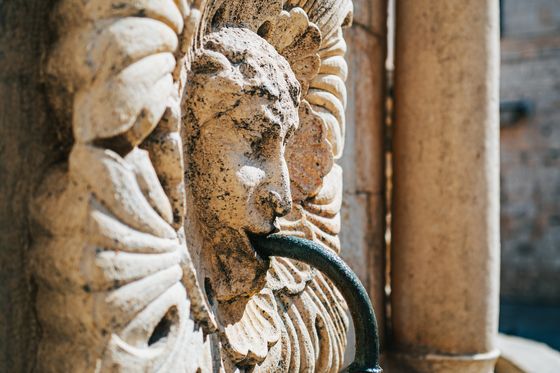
[193,99,295,234]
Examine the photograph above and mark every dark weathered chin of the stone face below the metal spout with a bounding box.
[203,228,270,302]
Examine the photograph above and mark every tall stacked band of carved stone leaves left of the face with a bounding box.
[33,0,213,372]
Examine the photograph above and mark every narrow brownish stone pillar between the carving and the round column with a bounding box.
[340,0,387,354]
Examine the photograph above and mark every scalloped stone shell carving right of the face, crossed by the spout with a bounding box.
[194,0,351,372]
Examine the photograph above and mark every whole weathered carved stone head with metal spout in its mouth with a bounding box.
[185,28,300,300]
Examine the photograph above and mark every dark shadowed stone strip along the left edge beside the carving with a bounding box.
[0,0,56,372]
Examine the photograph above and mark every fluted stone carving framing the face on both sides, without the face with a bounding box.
[32,0,351,372]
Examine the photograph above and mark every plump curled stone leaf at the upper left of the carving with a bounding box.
[47,0,183,147]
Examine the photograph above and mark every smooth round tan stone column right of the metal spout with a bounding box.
[391,0,499,373]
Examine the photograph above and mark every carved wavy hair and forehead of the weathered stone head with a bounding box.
[187,28,301,125]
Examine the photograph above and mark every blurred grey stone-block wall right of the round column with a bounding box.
[500,0,560,303]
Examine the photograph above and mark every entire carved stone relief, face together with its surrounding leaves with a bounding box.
[30,0,352,372]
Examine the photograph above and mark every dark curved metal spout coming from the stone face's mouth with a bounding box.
[251,234,382,373]
